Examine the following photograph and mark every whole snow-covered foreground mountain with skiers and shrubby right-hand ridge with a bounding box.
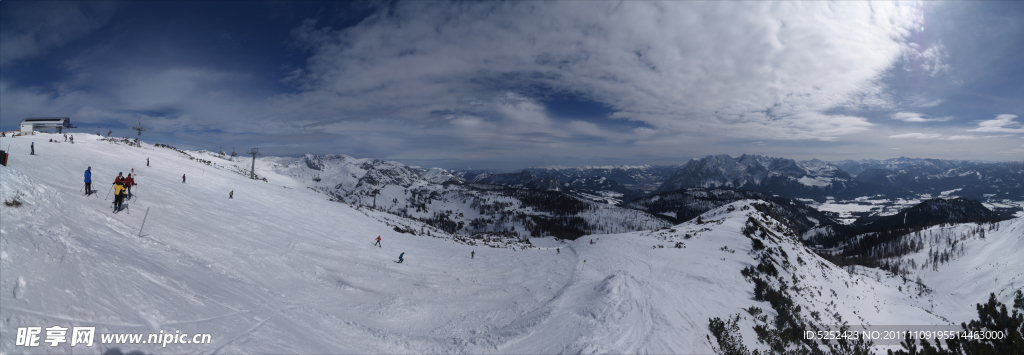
[0,134,1024,354]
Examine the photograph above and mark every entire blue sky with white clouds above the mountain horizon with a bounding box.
[0,0,1024,169]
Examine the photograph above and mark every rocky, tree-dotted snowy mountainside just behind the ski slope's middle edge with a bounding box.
[267,154,667,240]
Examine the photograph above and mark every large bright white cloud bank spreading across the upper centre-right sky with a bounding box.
[292,2,916,140]
